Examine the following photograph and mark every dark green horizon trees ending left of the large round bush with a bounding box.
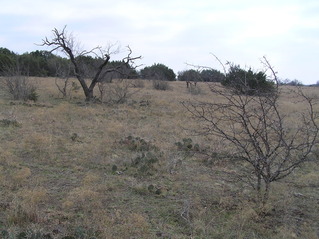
[0,47,230,82]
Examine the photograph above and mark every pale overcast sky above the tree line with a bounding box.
[0,0,319,84]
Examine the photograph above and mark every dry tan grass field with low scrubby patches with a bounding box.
[0,78,319,239]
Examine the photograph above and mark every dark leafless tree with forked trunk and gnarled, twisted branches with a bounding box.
[41,26,141,101]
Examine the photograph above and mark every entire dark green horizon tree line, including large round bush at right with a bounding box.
[0,47,302,92]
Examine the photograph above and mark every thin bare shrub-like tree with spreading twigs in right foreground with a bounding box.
[183,58,319,205]
